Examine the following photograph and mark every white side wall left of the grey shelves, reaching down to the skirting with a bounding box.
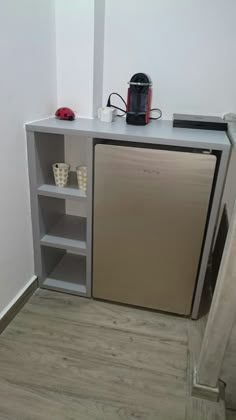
[0,0,56,318]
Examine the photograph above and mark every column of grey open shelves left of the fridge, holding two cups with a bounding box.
[28,132,93,297]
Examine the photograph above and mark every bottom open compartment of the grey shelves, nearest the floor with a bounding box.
[41,247,87,296]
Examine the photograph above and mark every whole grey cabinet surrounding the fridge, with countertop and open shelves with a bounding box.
[26,117,230,318]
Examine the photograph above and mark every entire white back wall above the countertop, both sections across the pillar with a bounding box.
[56,0,236,118]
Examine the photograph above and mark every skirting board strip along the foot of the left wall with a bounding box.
[0,278,38,334]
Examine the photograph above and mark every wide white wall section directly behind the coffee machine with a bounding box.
[103,0,236,118]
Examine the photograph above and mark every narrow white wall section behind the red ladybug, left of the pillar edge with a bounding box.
[56,0,94,117]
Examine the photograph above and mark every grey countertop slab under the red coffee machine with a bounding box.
[26,117,231,150]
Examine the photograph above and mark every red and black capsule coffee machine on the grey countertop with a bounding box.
[126,73,152,125]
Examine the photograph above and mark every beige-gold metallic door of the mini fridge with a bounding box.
[93,144,216,315]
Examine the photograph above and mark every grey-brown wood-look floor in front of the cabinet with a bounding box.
[0,290,223,420]
